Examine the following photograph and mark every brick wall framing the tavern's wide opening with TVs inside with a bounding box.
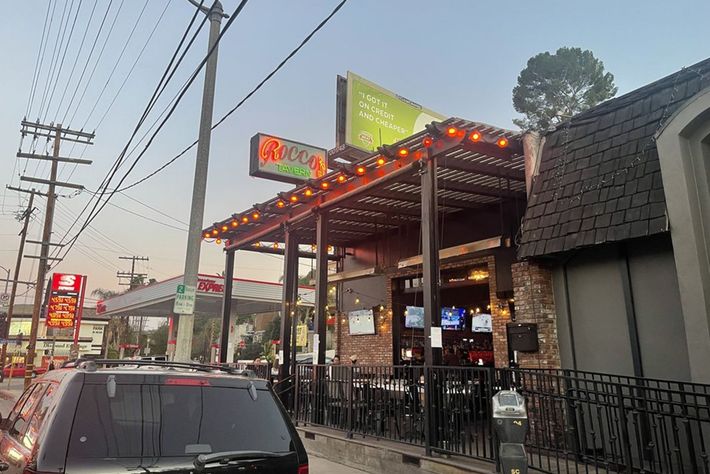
[335,255,510,367]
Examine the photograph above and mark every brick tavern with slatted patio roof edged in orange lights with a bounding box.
[203,118,558,374]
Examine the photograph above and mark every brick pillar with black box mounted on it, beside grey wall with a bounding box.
[512,261,560,368]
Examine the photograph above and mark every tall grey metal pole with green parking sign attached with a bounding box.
[175,0,228,362]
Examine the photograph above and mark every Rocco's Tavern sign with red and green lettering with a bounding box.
[249,133,328,184]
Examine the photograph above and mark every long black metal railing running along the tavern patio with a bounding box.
[284,365,710,474]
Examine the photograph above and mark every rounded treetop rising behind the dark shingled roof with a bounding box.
[513,47,617,131]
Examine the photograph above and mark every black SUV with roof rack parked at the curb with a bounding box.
[0,361,308,474]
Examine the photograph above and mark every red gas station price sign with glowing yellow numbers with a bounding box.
[47,273,86,328]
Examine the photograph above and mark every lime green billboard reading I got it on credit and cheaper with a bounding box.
[345,71,446,151]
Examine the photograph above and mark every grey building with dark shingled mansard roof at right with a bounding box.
[516,60,710,383]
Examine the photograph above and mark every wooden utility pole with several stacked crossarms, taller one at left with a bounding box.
[17,120,94,388]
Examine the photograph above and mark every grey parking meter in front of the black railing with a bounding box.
[493,390,528,474]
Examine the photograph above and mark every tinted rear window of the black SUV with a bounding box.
[68,380,294,459]
